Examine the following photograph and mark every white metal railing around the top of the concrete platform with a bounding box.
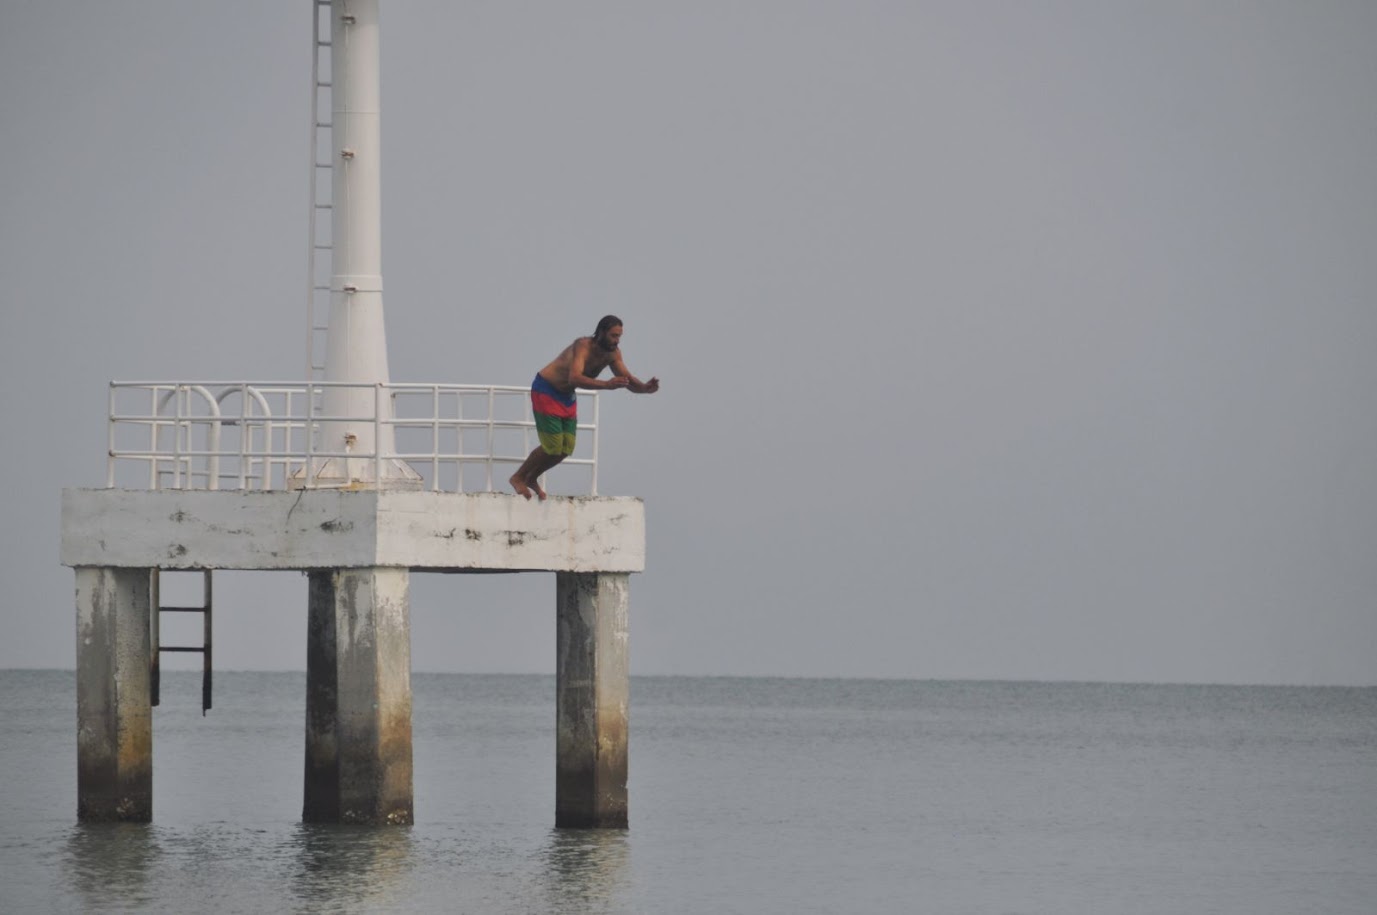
[106,382,598,495]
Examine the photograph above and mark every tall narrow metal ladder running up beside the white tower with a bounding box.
[306,0,335,382]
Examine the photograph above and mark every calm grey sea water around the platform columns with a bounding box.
[0,671,1377,915]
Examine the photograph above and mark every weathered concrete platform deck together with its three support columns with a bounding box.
[61,488,646,828]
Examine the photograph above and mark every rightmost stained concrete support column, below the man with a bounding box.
[555,572,631,830]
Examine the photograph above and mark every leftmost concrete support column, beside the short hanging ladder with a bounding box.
[76,566,153,823]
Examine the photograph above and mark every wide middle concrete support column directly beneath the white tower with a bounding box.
[302,568,413,824]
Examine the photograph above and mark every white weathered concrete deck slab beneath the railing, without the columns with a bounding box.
[61,489,646,572]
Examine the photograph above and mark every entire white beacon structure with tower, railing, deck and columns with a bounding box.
[61,0,644,828]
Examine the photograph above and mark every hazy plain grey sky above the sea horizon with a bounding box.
[0,0,1377,685]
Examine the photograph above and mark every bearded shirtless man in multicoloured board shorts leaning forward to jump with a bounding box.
[508,314,660,502]
